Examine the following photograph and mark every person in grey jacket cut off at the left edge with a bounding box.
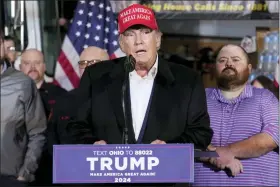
[0,31,47,187]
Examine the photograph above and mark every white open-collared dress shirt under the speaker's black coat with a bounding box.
[129,57,158,140]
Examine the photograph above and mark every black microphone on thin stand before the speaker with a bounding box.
[122,55,136,144]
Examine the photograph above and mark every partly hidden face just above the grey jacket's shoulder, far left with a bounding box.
[4,36,17,67]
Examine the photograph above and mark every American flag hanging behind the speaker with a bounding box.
[54,0,124,91]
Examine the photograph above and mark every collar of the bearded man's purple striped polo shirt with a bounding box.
[210,84,253,104]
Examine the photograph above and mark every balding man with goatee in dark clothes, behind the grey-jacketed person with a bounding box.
[20,49,67,117]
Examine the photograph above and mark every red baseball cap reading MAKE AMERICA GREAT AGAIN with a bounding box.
[118,4,158,33]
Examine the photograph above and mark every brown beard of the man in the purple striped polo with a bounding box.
[216,67,250,91]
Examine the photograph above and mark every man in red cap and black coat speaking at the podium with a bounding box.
[67,4,213,152]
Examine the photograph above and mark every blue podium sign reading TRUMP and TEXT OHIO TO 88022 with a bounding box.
[53,144,194,184]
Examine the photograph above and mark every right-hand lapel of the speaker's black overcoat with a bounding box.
[143,59,175,143]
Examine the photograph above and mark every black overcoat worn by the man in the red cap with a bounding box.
[68,58,213,149]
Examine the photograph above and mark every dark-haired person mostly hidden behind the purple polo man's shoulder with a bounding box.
[251,75,279,99]
